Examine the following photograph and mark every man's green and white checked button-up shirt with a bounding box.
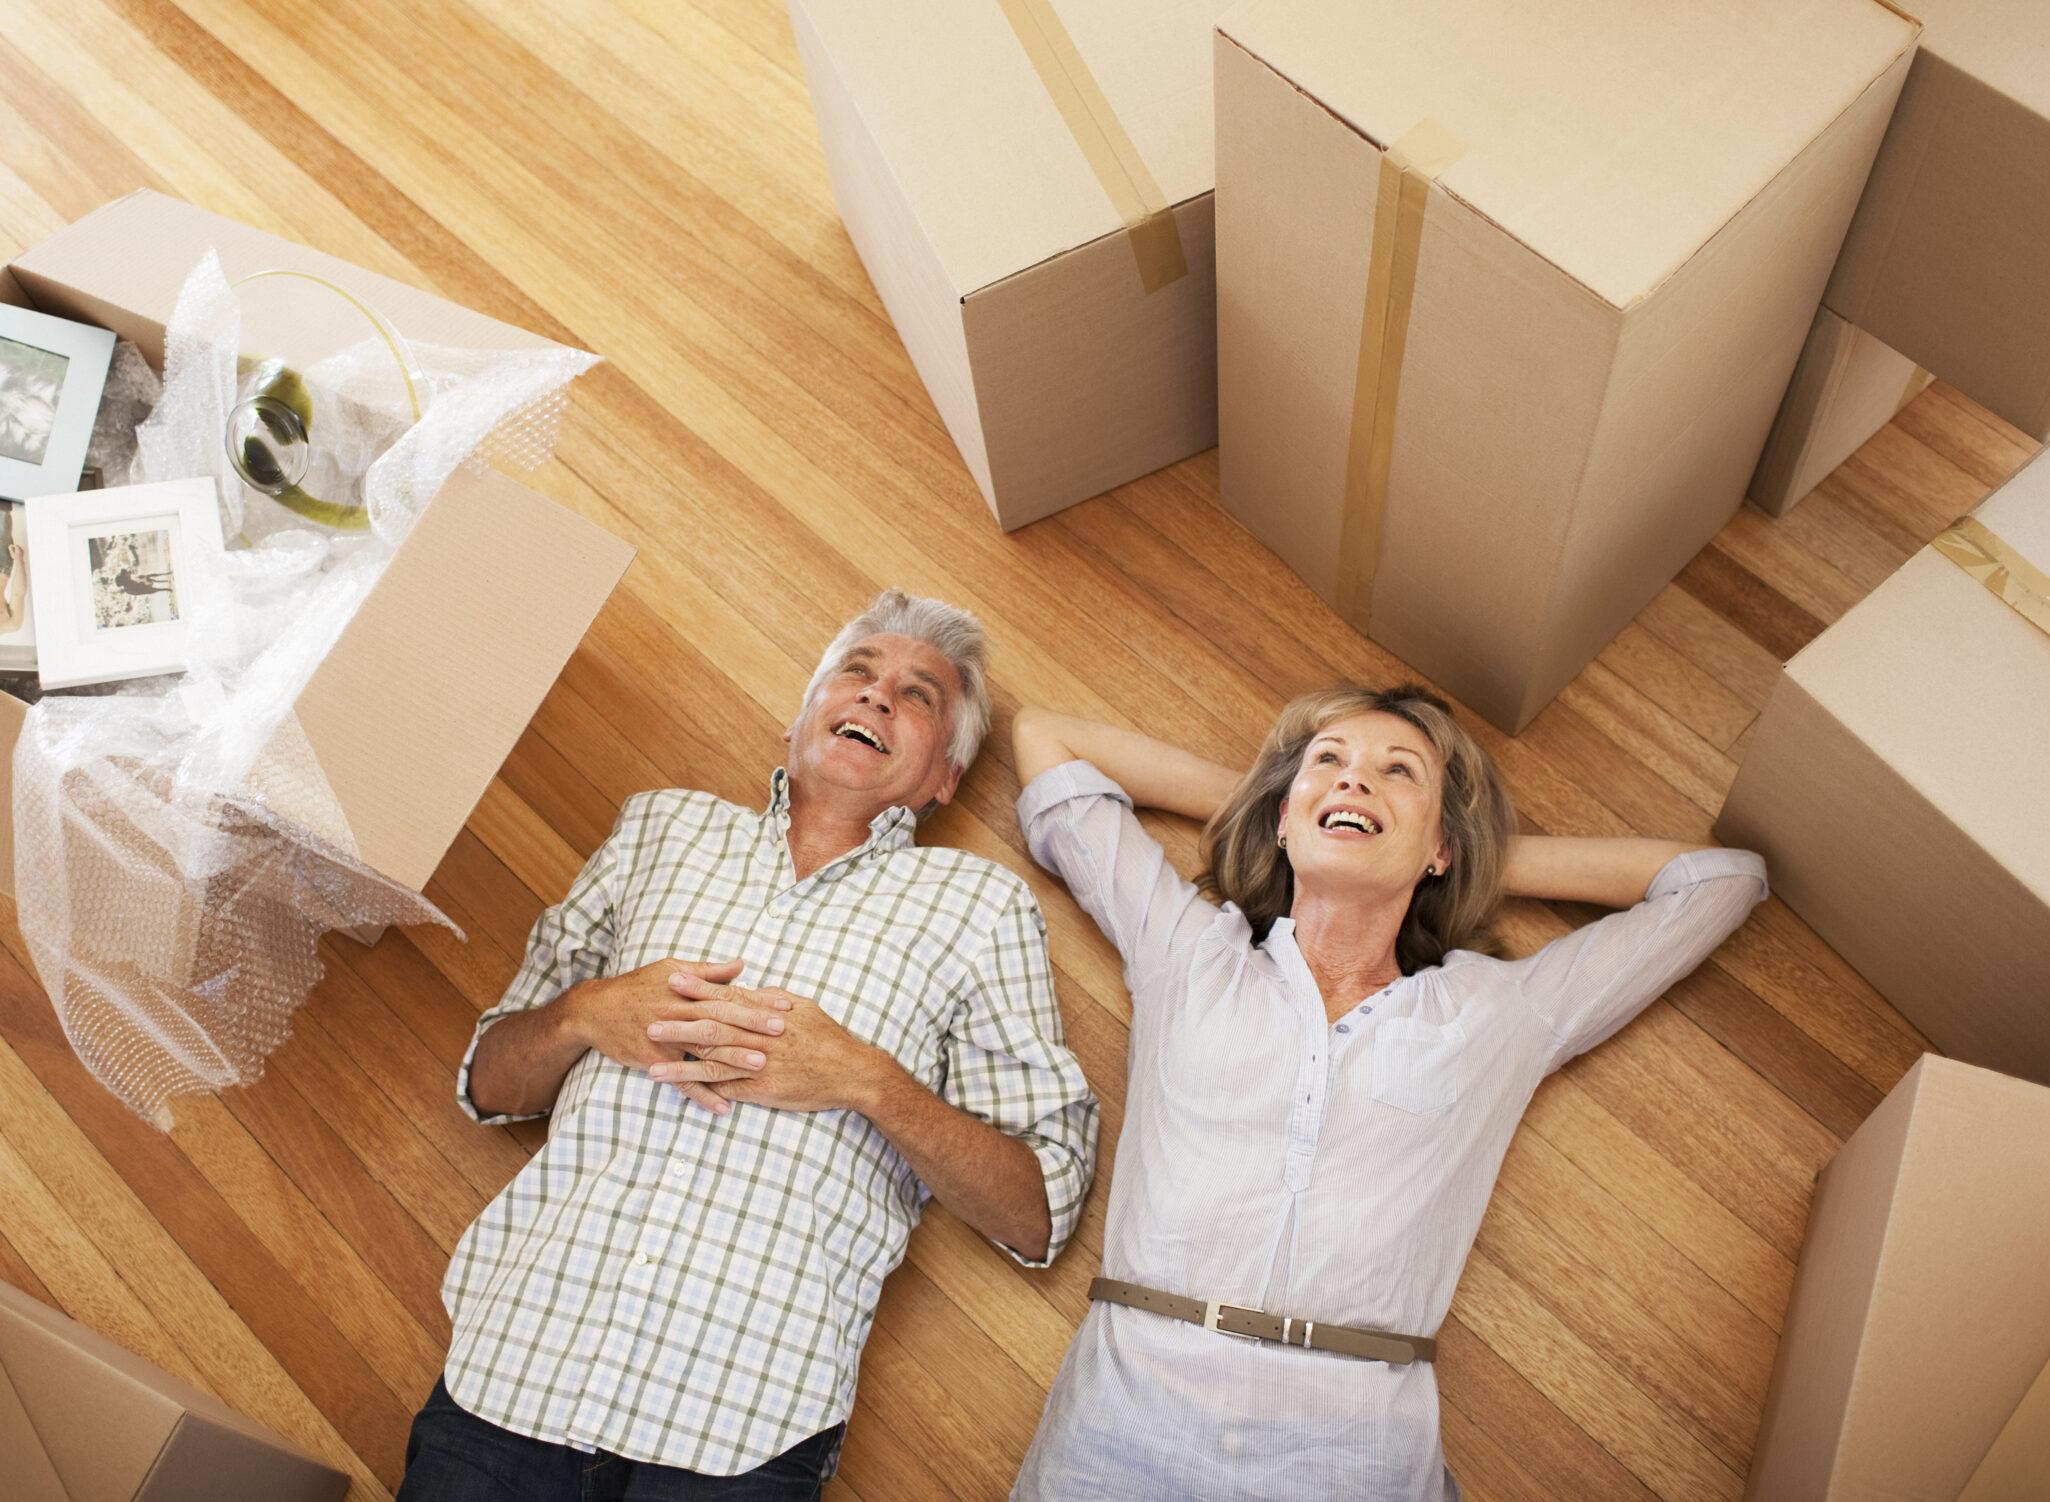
[443,770,1097,1475]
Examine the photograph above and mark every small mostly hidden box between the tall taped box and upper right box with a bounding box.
[1751,307,1933,516]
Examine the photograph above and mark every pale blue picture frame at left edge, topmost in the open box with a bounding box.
[0,303,115,500]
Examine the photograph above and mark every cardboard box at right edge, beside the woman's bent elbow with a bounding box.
[1716,438,2050,1084]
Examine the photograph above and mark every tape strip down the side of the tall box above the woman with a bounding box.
[1339,119,1466,631]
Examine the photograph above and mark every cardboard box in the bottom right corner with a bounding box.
[1745,1053,2050,1502]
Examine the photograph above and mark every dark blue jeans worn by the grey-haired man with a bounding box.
[398,1379,847,1502]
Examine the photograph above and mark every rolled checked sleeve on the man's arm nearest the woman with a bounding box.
[941,885,1097,1266]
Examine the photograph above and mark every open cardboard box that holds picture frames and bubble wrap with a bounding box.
[0,191,633,891]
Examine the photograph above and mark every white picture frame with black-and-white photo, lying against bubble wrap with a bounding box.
[25,477,221,689]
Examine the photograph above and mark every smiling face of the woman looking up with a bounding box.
[1279,711,1449,891]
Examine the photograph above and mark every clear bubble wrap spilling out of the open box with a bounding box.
[14,254,595,1129]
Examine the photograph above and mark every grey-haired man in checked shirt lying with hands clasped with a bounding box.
[400,590,1097,1502]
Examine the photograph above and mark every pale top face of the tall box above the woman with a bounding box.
[1218,0,1917,307]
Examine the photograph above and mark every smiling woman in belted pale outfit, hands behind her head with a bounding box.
[1013,686,1765,1502]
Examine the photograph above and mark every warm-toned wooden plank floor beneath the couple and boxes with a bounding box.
[0,0,2032,1502]
